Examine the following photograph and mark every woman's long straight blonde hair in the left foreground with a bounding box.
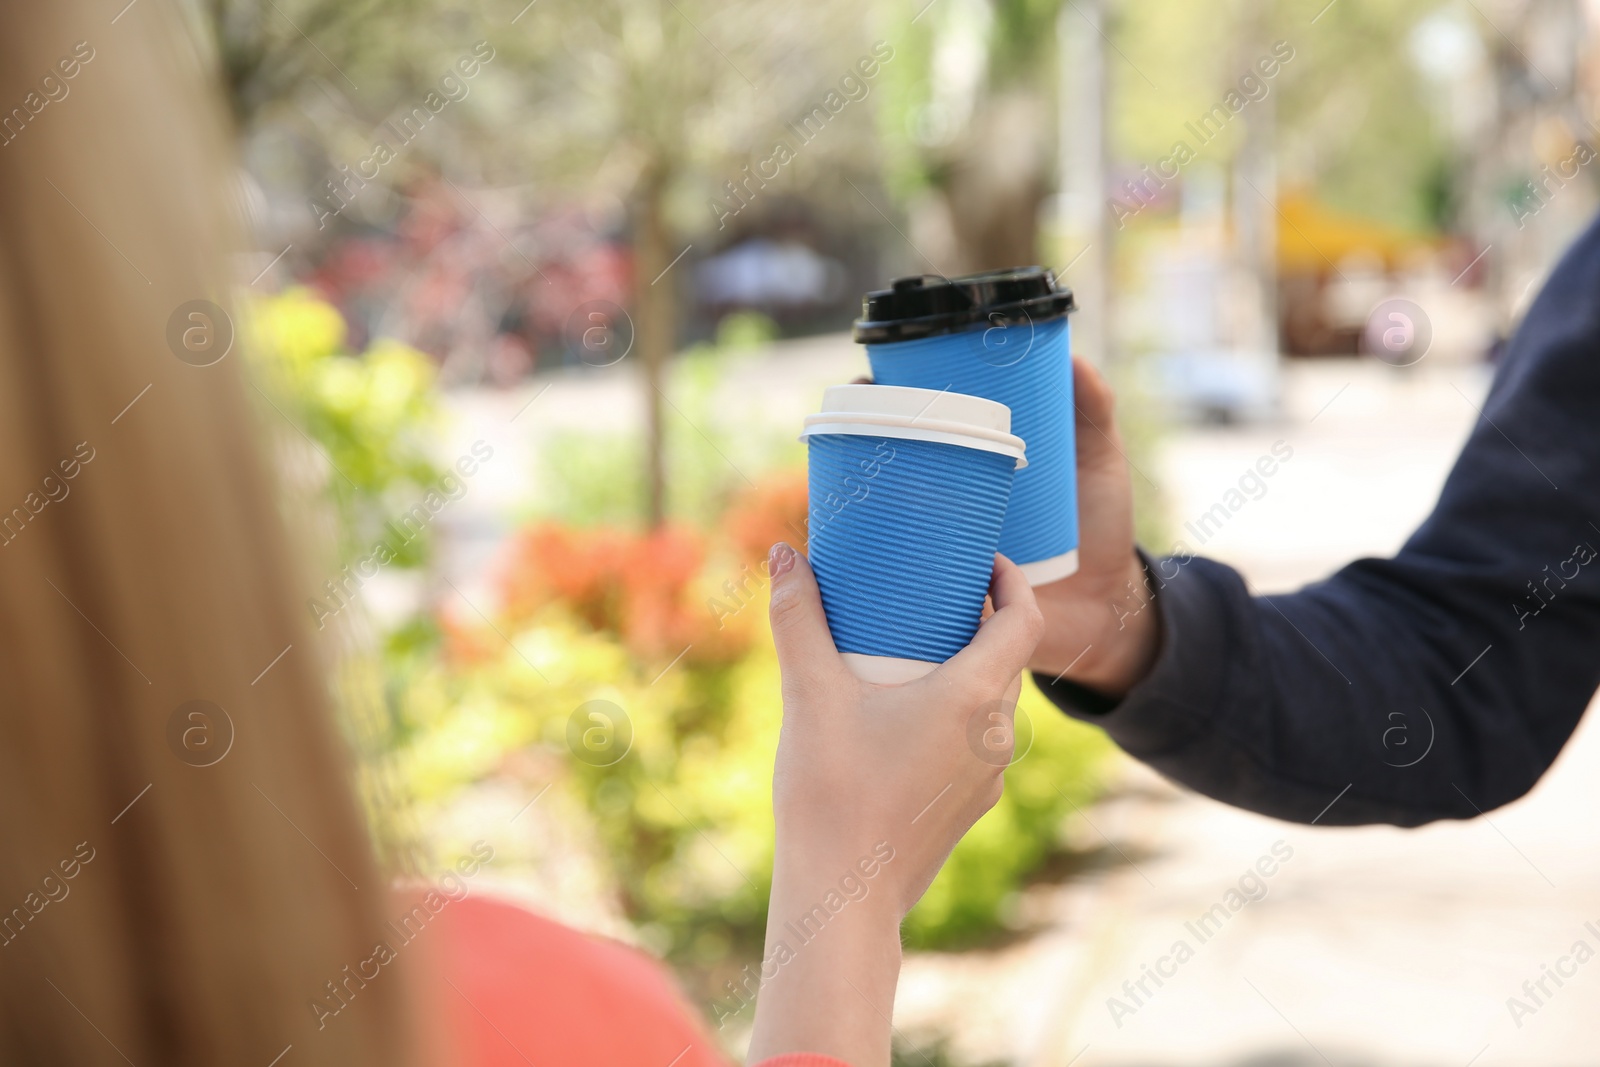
[0,3,413,1067]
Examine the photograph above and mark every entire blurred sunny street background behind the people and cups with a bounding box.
[219,0,1600,1067]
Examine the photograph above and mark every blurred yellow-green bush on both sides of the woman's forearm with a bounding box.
[393,585,1109,971]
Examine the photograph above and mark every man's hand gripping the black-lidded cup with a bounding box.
[1027,360,1160,696]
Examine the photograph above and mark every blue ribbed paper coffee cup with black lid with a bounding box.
[854,267,1078,585]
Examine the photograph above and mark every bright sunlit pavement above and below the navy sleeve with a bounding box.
[898,362,1600,1067]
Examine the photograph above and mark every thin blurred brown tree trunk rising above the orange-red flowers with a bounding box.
[634,162,677,530]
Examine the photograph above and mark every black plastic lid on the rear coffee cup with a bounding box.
[851,267,1077,344]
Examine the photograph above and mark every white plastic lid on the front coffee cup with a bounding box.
[800,386,1027,469]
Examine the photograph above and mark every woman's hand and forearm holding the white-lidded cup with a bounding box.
[750,544,1043,1067]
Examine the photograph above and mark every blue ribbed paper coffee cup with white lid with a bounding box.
[802,386,1026,683]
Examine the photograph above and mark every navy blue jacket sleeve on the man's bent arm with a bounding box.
[1035,222,1600,825]
